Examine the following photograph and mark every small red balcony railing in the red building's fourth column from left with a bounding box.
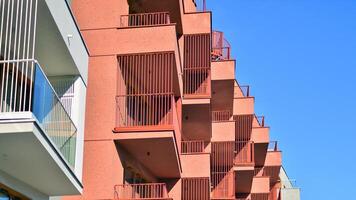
[234,141,255,165]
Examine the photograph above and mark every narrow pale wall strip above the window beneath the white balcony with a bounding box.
[0,171,49,200]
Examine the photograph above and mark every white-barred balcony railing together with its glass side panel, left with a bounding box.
[0,59,77,168]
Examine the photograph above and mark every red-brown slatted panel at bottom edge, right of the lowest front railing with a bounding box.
[182,177,210,200]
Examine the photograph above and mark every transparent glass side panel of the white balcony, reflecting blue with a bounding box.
[32,64,77,167]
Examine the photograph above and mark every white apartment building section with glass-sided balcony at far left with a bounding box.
[0,0,89,200]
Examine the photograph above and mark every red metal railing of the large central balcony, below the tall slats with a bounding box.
[116,94,175,128]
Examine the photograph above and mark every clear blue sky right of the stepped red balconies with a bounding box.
[207,0,356,200]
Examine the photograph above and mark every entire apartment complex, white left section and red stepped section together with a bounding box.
[0,0,298,200]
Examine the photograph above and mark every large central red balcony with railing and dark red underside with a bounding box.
[114,94,181,178]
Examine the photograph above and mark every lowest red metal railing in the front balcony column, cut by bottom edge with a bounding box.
[114,183,170,200]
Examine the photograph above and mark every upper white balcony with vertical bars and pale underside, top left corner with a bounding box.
[0,0,89,83]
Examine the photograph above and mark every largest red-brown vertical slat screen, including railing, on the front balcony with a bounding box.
[116,52,175,128]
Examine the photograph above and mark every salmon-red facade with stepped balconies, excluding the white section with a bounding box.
[60,0,282,200]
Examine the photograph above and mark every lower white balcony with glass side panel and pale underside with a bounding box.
[0,60,82,196]
